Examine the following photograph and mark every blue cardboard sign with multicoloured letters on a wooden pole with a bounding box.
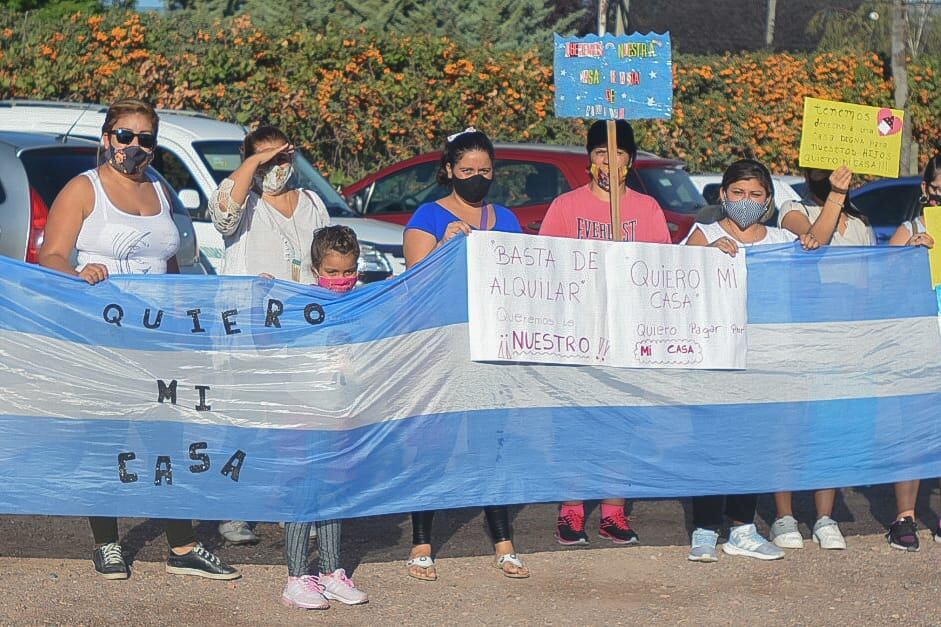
[555,32,673,120]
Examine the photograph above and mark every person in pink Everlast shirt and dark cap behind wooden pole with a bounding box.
[539,120,670,545]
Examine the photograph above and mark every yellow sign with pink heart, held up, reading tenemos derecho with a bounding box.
[800,98,905,178]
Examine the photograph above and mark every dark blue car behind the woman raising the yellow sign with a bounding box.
[850,176,921,245]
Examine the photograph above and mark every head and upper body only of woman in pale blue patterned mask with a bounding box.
[684,159,820,257]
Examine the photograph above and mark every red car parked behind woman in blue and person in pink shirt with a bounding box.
[343,144,705,242]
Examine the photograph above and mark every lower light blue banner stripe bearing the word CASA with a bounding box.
[0,394,941,520]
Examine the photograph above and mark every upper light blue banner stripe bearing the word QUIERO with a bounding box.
[0,237,937,351]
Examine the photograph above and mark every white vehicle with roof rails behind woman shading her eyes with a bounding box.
[0,100,405,281]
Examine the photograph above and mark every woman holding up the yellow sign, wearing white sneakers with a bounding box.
[771,166,876,549]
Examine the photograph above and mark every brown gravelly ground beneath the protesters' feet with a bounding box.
[0,483,941,625]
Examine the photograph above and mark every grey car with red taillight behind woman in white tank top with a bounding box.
[0,131,205,274]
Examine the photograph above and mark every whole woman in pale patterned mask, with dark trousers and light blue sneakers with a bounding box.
[685,159,820,562]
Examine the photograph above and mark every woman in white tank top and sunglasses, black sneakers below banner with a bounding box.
[39,99,240,579]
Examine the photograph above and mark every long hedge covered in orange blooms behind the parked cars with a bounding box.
[0,11,941,183]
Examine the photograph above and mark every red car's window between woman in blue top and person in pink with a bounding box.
[487,159,571,208]
